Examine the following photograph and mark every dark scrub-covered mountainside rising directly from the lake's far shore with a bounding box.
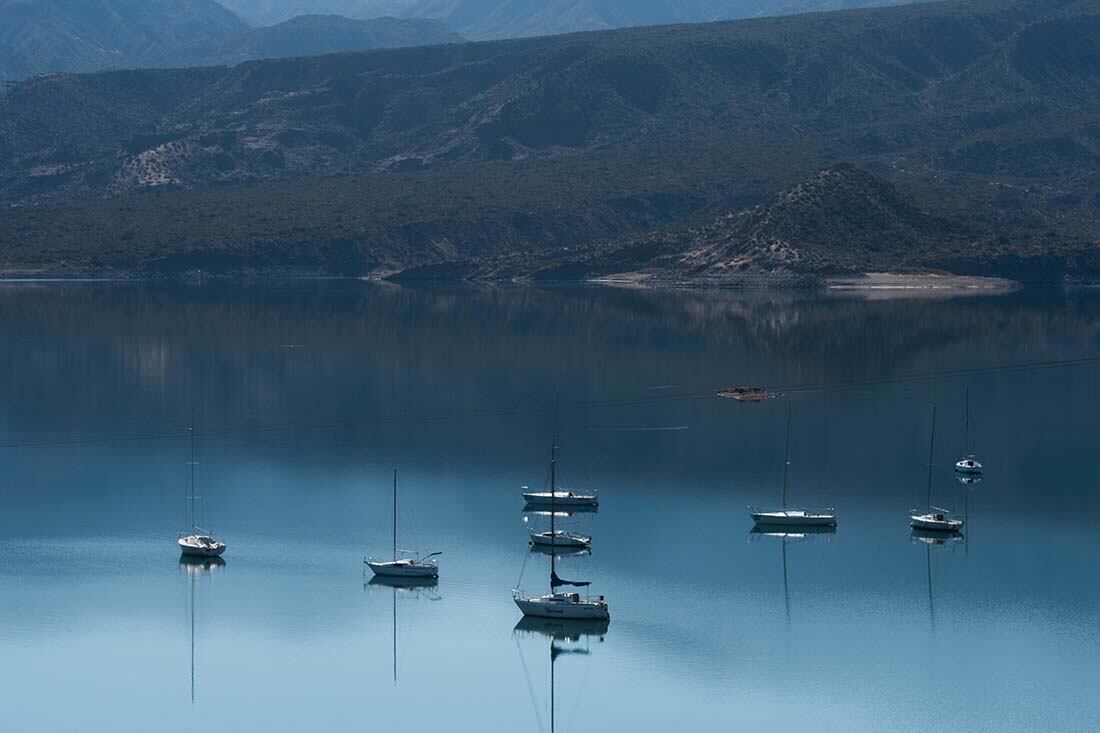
[0,0,1100,284]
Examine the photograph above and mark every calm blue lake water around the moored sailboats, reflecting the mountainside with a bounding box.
[0,283,1100,733]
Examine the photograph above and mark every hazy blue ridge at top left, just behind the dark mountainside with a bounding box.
[0,0,462,80]
